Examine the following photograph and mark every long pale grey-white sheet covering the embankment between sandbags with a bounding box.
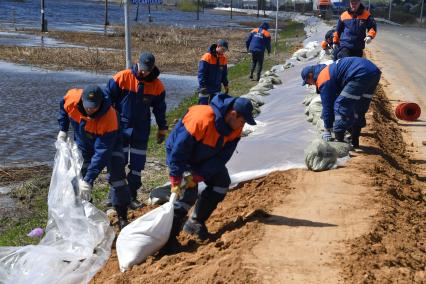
[227,16,330,184]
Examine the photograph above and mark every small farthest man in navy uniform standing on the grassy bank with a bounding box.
[246,22,271,81]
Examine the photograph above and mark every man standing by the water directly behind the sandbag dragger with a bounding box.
[198,39,229,105]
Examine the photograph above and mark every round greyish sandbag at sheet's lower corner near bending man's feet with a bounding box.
[305,138,337,172]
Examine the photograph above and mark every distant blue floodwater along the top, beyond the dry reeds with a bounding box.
[0,0,264,32]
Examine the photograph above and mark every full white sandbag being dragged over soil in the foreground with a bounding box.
[116,193,176,272]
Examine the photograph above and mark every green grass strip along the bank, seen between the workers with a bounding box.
[0,21,304,246]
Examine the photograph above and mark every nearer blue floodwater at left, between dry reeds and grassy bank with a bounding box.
[0,62,197,167]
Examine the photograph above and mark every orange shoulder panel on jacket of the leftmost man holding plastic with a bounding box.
[64,89,118,135]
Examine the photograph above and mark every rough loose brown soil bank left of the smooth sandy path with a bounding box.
[92,170,297,283]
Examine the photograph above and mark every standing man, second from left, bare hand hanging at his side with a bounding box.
[106,52,168,209]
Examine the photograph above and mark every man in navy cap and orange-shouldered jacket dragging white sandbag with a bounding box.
[163,94,256,253]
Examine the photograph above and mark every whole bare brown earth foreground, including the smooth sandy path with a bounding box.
[92,85,426,283]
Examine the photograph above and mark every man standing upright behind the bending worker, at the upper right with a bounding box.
[333,0,377,59]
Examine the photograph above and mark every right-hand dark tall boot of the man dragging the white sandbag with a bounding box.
[183,196,219,240]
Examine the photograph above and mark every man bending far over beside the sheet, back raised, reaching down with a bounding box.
[301,57,381,148]
